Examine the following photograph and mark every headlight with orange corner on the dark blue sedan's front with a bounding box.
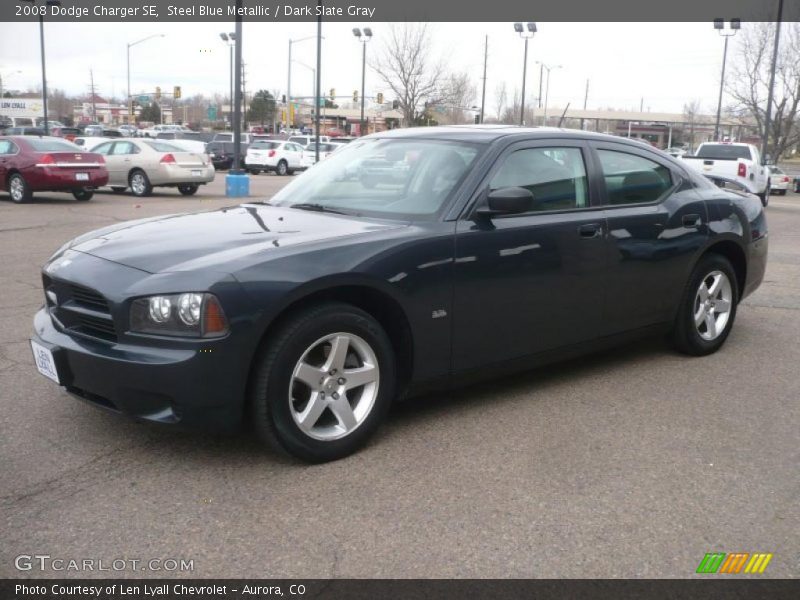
[131,292,228,338]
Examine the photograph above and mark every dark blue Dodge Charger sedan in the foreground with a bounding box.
[31,126,767,461]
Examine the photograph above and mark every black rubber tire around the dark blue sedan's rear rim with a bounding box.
[672,253,739,356]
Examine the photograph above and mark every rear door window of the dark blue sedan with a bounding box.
[597,150,672,204]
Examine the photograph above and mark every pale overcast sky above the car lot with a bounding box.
[0,22,748,115]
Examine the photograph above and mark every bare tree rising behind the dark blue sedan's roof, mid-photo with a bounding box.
[370,23,444,126]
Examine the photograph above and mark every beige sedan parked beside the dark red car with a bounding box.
[93,138,214,197]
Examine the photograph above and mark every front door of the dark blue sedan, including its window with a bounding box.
[453,140,606,371]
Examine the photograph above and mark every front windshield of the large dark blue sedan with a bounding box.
[270,139,480,220]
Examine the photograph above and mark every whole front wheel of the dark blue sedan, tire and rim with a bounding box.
[250,303,396,462]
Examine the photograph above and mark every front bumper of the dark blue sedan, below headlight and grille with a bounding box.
[31,309,244,432]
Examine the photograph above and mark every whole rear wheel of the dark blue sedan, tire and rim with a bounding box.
[672,254,739,356]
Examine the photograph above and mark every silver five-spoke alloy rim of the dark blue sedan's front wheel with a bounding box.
[289,333,380,441]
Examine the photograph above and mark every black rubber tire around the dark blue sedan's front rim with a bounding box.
[249,303,397,463]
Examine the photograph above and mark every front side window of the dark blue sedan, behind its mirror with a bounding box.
[489,147,589,211]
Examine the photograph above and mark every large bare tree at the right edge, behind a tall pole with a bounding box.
[726,23,800,159]
